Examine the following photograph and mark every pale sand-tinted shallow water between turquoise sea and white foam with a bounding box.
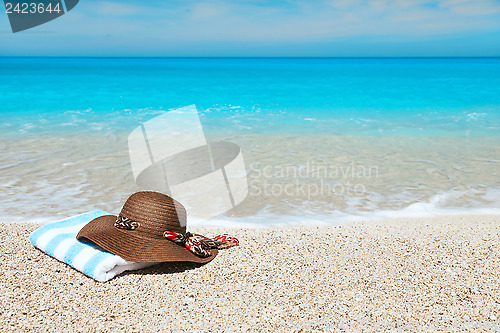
[0,131,500,221]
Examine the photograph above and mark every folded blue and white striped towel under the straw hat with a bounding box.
[30,210,155,282]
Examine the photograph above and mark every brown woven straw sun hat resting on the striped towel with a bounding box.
[76,192,218,263]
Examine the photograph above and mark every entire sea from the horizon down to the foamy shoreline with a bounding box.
[0,58,500,224]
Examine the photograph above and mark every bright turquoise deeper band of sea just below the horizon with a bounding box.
[0,58,500,136]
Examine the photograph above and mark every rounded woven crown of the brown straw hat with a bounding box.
[120,191,187,238]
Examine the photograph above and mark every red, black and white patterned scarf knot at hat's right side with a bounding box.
[163,231,239,258]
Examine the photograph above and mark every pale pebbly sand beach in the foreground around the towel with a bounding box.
[0,216,500,332]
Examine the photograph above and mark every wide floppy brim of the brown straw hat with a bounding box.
[76,215,218,264]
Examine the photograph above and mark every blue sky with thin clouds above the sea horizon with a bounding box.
[0,0,500,57]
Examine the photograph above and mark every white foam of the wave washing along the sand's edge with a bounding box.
[6,188,500,229]
